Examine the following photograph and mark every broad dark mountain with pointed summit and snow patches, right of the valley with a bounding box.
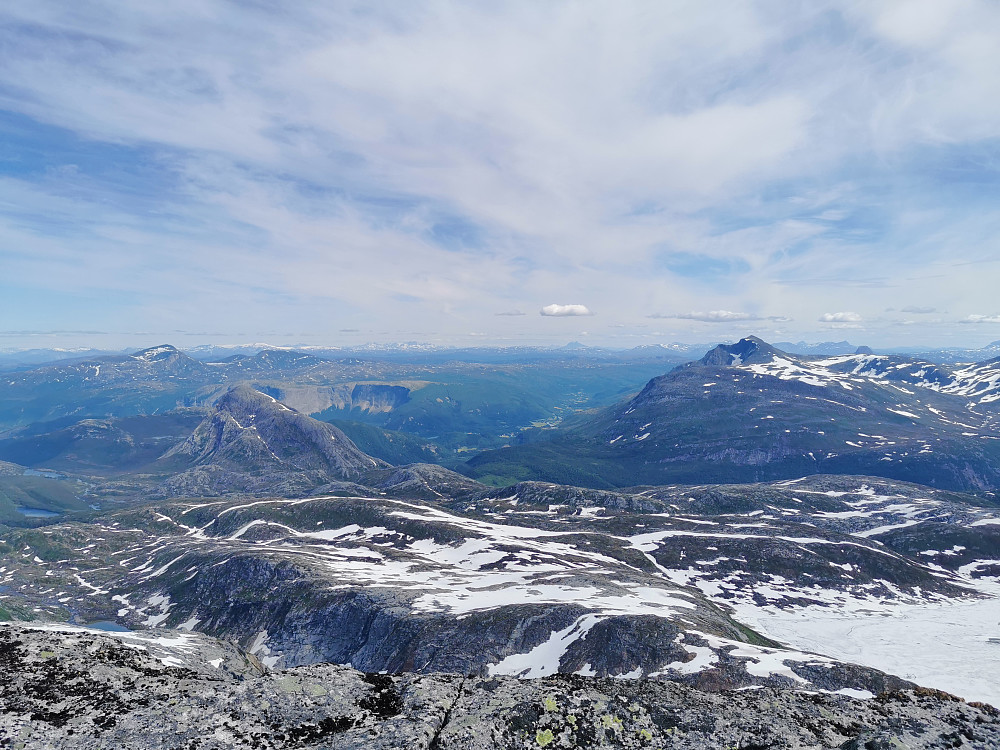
[469,337,1000,492]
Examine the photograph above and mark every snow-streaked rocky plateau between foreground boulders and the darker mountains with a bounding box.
[0,478,1000,698]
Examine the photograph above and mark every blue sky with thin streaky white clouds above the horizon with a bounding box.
[0,0,1000,348]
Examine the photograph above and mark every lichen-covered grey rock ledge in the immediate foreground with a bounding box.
[0,624,1000,750]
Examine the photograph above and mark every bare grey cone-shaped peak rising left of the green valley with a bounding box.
[157,385,388,494]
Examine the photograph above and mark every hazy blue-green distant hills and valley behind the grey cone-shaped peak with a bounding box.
[0,345,682,465]
